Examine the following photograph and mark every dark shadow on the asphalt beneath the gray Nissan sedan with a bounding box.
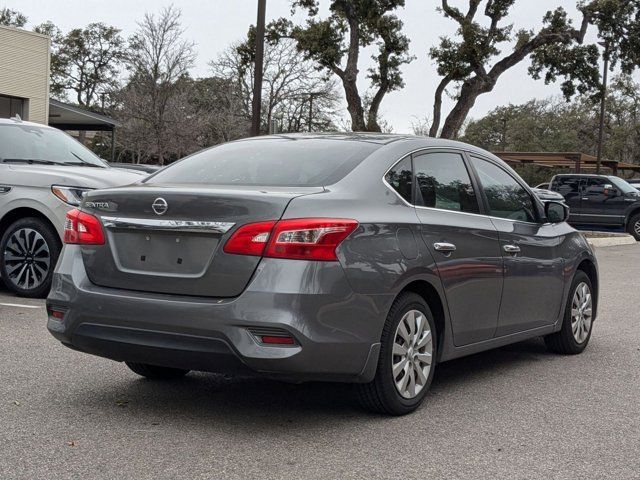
[65,340,548,422]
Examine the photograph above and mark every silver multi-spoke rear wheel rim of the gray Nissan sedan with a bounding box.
[391,310,433,399]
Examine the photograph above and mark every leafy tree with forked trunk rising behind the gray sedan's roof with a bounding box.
[268,0,413,132]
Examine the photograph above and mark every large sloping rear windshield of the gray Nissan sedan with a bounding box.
[145,137,380,187]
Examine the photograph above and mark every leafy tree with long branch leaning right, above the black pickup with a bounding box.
[430,0,640,138]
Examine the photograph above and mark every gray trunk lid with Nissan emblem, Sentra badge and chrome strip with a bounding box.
[82,184,323,297]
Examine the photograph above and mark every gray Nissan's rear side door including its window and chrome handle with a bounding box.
[413,151,503,346]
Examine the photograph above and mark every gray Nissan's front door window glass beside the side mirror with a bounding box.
[471,157,537,223]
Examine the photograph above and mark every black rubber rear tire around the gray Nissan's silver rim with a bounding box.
[356,292,438,415]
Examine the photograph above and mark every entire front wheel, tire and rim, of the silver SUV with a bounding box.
[0,217,62,298]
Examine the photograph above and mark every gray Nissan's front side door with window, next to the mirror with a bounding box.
[470,155,564,337]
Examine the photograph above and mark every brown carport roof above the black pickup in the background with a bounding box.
[493,152,640,175]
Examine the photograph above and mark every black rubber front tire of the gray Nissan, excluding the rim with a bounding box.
[544,270,595,355]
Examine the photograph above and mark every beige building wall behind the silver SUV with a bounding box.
[0,26,51,124]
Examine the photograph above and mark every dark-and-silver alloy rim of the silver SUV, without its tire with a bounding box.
[4,228,51,290]
